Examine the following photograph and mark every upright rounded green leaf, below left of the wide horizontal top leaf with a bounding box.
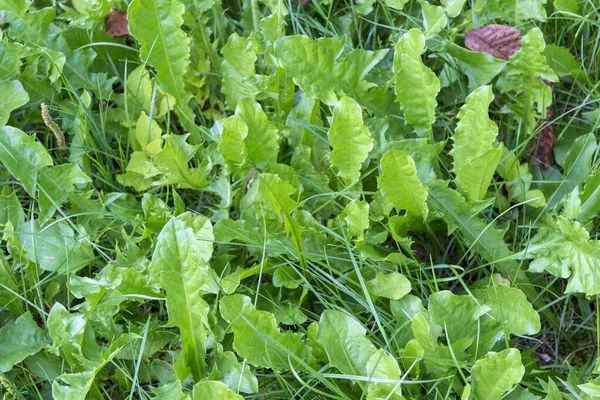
[236,99,279,170]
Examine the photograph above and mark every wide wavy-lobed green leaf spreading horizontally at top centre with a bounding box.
[274,35,387,105]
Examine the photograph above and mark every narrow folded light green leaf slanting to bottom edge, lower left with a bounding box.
[52,333,140,400]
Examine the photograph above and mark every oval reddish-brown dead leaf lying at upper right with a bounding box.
[465,24,521,60]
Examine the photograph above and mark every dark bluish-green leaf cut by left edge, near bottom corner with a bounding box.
[0,311,48,372]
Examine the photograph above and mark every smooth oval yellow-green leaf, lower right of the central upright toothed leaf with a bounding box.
[378,150,428,220]
